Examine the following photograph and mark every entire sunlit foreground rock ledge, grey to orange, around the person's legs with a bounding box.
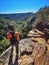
[0,29,49,65]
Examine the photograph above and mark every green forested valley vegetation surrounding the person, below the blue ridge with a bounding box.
[0,15,31,54]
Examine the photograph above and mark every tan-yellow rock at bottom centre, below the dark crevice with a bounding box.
[18,55,34,65]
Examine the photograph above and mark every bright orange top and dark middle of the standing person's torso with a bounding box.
[7,32,20,42]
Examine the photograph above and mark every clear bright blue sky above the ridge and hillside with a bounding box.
[0,0,49,13]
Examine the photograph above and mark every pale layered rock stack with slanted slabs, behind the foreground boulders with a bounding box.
[28,29,44,38]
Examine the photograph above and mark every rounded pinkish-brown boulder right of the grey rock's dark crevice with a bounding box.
[33,43,46,57]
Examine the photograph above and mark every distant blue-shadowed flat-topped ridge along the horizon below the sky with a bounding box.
[0,12,34,20]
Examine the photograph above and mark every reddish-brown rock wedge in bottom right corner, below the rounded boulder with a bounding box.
[35,51,49,65]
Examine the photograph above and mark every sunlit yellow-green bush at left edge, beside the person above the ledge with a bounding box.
[0,37,10,54]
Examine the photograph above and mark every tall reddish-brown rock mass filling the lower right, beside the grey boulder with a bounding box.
[33,43,49,65]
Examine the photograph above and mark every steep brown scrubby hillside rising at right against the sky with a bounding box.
[31,6,49,29]
